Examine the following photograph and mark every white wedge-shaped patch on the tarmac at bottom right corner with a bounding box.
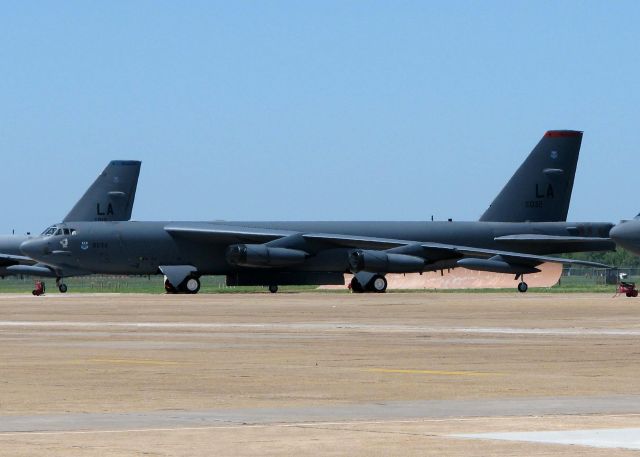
[458,428,640,450]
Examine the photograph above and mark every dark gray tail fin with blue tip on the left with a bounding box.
[63,160,141,222]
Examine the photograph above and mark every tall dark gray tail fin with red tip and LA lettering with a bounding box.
[480,130,582,222]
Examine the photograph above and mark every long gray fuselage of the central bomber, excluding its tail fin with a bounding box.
[23,221,613,275]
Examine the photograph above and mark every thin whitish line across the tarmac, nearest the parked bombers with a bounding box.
[0,321,640,337]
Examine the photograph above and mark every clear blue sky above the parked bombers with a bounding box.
[0,1,640,233]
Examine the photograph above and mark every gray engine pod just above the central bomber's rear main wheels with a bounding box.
[349,249,425,273]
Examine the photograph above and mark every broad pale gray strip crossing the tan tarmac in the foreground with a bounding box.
[0,396,640,436]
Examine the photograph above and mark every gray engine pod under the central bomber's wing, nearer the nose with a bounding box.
[226,244,309,267]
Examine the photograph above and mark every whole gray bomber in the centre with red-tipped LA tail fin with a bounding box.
[20,130,614,293]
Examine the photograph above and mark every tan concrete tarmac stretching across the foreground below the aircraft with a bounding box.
[0,293,640,456]
